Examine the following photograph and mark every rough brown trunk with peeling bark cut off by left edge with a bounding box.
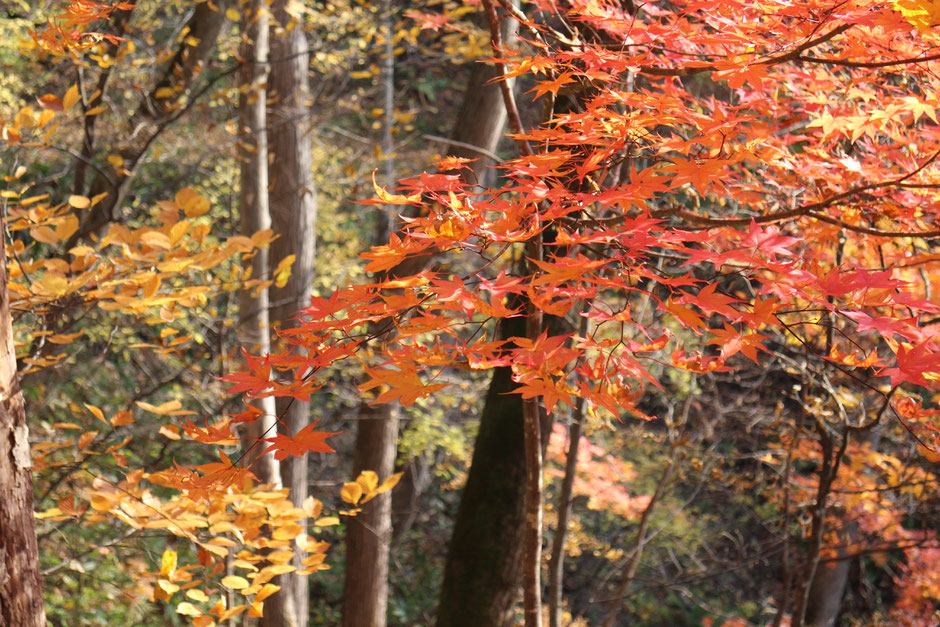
[0,216,46,627]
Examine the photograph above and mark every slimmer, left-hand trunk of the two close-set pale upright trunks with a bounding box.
[238,0,294,627]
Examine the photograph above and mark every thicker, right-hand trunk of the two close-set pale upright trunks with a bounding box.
[268,0,317,627]
